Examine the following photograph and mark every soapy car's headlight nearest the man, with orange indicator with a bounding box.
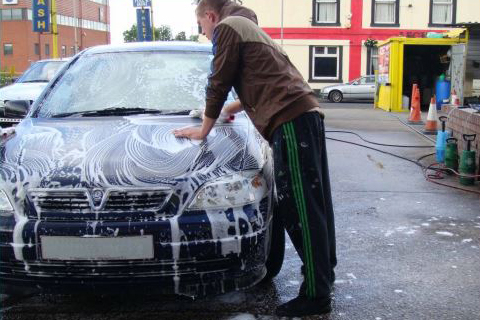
[188,170,268,210]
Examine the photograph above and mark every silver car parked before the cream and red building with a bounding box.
[321,76,375,102]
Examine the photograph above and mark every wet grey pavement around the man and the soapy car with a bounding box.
[0,103,480,320]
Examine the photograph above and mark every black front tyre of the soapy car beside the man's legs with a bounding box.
[264,208,285,281]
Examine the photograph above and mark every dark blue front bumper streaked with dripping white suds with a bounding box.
[0,199,271,296]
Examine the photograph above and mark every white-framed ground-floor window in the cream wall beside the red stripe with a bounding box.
[309,46,343,82]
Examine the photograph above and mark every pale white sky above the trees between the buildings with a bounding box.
[110,0,198,44]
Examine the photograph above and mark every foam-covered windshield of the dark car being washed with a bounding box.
[33,51,233,117]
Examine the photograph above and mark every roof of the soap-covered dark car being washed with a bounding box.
[84,41,212,54]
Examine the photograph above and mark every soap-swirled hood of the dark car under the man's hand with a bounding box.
[0,114,264,198]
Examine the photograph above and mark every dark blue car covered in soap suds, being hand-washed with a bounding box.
[0,42,285,296]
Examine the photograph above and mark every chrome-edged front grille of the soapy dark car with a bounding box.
[29,188,172,220]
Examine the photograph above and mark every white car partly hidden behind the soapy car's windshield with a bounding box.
[0,59,68,103]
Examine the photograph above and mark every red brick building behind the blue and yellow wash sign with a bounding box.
[0,0,110,72]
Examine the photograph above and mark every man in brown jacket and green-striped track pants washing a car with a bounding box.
[174,0,336,316]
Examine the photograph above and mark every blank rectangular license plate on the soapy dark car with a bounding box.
[40,235,153,260]
